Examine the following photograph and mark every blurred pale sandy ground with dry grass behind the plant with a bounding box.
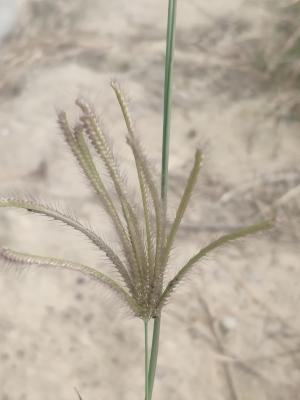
[0,0,300,400]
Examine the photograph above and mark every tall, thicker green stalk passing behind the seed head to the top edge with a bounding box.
[147,0,177,400]
